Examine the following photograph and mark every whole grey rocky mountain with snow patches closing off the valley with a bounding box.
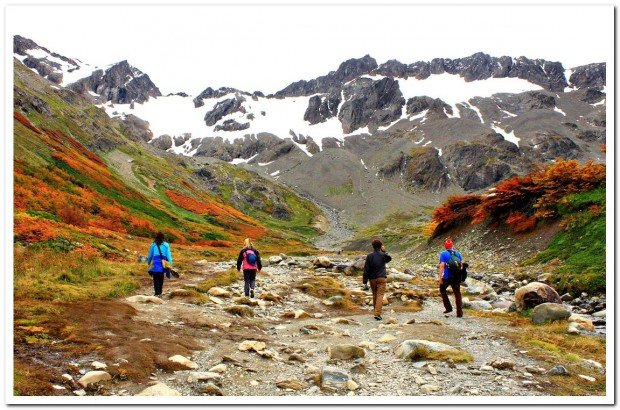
[15,37,606,227]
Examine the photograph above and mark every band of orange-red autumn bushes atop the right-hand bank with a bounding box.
[431,160,605,236]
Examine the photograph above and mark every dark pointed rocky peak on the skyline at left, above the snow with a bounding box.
[69,60,161,104]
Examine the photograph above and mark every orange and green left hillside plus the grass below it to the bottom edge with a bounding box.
[13,62,320,394]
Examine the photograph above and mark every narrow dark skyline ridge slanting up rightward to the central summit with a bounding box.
[275,55,377,98]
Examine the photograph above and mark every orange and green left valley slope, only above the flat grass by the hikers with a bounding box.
[14,58,318,253]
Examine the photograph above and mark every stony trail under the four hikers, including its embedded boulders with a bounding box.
[61,251,604,396]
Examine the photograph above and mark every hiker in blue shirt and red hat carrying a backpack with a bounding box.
[439,238,463,317]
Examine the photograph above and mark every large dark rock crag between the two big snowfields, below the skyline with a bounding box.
[338,77,405,134]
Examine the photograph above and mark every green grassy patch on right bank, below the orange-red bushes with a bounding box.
[529,187,606,294]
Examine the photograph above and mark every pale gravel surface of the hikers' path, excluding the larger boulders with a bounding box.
[112,256,556,396]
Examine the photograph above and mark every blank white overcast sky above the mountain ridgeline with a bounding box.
[7,6,614,94]
